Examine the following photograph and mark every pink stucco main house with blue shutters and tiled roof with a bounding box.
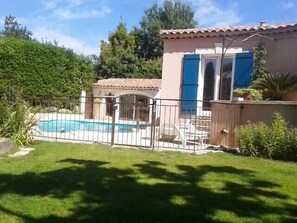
[160,22,297,116]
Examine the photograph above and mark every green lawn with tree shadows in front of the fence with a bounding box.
[0,142,297,223]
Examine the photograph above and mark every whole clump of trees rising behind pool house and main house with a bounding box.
[95,0,197,78]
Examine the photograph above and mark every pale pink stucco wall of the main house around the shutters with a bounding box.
[161,33,297,99]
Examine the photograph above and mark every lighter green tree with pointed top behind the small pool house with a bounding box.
[97,23,139,78]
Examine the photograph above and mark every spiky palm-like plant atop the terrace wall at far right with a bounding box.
[252,73,297,100]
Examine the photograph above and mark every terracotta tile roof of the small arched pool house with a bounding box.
[93,78,161,90]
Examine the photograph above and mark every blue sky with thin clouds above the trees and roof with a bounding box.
[0,0,297,55]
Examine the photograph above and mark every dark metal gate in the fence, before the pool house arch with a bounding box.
[111,95,155,147]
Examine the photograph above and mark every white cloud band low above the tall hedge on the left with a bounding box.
[34,28,99,55]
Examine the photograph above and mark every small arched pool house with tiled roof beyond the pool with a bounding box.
[93,78,161,122]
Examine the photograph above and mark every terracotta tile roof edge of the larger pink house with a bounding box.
[160,23,297,39]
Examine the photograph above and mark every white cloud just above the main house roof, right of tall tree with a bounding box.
[190,0,241,26]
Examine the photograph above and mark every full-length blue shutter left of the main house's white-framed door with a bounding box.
[181,54,200,115]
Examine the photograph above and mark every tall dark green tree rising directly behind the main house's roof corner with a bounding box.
[133,0,197,60]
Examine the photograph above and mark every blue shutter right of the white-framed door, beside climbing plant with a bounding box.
[233,52,254,89]
